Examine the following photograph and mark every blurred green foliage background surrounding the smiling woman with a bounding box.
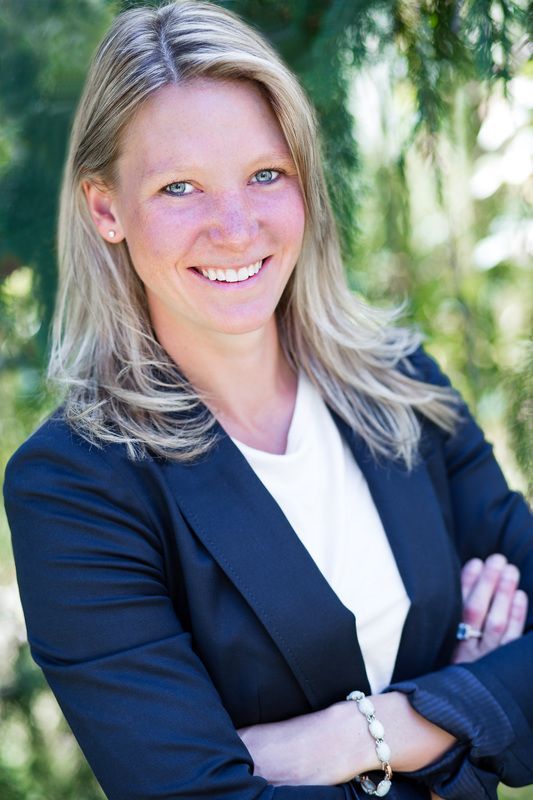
[0,0,533,800]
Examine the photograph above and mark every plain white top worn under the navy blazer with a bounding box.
[232,372,410,693]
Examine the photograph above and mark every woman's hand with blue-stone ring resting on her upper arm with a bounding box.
[452,553,528,664]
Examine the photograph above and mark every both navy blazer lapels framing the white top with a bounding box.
[162,409,458,710]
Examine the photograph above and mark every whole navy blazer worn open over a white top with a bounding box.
[5,351,533,800]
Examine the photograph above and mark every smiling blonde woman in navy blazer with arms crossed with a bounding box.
[6,2,533,800]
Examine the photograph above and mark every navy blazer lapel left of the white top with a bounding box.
[165,423,370,710]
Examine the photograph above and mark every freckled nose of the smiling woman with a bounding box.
[209,193,259,251]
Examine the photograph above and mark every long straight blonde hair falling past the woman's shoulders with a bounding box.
[49,0,456,465]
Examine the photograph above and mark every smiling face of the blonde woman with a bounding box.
[88,79,305,344]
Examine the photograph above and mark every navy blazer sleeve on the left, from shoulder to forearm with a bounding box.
[4,421,353,800]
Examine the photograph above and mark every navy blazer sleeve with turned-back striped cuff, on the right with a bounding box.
[387,350,533,800]
